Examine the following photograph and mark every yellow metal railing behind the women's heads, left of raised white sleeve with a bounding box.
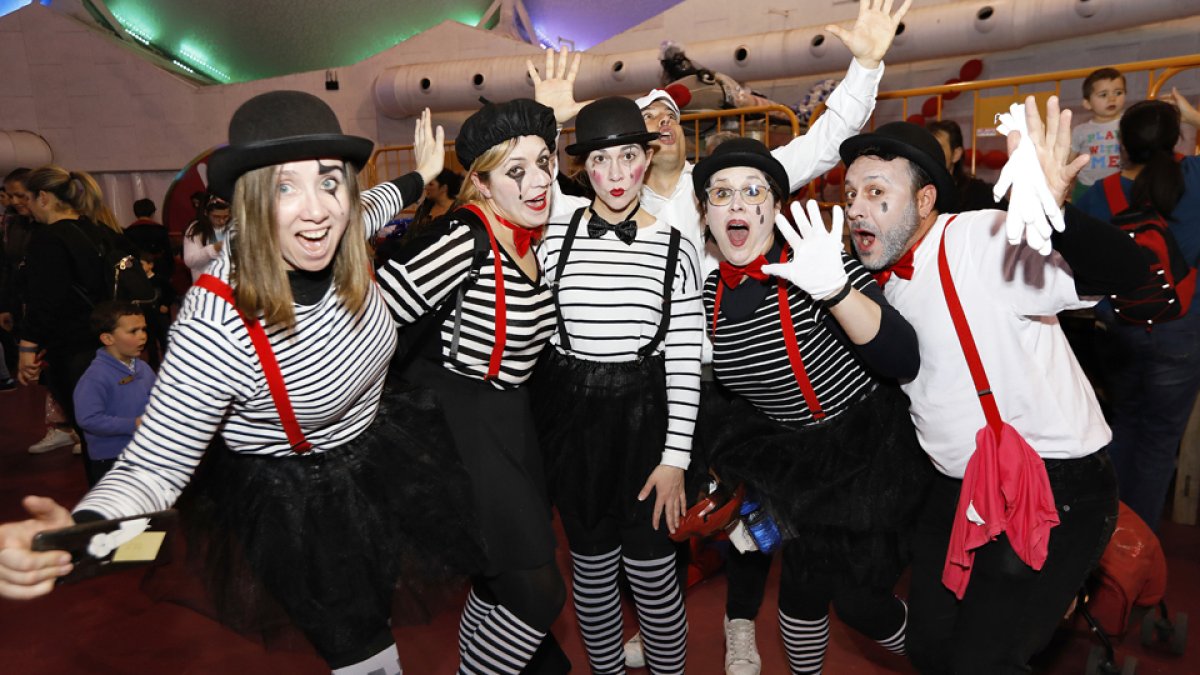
[362,106,800,187]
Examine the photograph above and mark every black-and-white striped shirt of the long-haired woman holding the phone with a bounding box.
[76,183,419,518]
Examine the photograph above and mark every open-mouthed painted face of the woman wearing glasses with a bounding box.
[704,167,779,267]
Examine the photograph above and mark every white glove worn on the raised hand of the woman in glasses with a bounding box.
[762,199,850,300]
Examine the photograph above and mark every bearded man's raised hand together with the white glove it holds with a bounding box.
[994,96,1090,255]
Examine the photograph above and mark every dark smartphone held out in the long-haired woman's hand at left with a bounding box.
[32,509,179,584]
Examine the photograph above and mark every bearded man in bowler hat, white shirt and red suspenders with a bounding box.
[841,97,1148,674]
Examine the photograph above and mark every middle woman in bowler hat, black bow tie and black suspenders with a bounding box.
[534,97,703,673]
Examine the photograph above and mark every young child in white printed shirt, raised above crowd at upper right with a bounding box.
[1070,68,1126,202]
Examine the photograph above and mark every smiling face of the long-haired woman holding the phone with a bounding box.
[275,160,350,271]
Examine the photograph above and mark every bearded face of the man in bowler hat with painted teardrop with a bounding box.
[846,155,920,271]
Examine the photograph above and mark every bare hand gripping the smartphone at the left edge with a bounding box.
[0,497,74,599]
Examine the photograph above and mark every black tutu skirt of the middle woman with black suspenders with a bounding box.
[532,348,667,527]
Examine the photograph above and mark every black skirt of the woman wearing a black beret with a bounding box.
[404,358,556,577]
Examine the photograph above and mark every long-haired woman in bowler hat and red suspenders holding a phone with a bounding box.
[0,91,479,675]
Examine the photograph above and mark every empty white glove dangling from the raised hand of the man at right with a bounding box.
[992,103,1066,256]
